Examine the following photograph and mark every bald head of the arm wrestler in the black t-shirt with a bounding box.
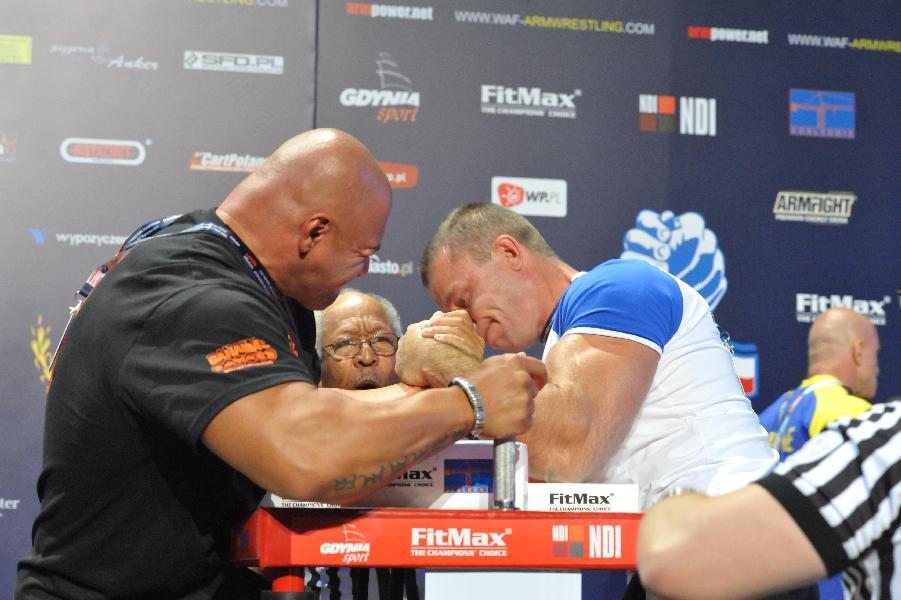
[216,129,391,309]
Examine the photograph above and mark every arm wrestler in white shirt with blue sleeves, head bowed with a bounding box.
[412,204,777,509]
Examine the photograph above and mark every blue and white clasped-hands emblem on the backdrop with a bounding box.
[620,210,727,310]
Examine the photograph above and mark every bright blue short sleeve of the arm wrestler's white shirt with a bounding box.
[554,259,683,351]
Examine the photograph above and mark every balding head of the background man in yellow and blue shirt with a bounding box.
[807,308,879,398]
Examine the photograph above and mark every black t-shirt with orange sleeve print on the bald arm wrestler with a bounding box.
[16,211,319,600]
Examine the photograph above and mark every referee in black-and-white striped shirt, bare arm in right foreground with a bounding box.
[637,396,901,599]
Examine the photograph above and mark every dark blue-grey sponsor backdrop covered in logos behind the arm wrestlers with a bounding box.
[0,0,901,589]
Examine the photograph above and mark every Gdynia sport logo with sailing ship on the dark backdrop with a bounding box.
[338,52,420,123]
